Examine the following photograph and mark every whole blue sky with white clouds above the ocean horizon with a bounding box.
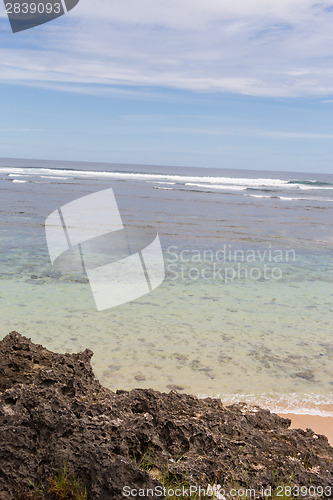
[0,0,333,173]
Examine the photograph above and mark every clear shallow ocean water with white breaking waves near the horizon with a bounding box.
[0,159,333,416]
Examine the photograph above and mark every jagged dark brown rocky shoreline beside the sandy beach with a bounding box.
[0,332,333,500]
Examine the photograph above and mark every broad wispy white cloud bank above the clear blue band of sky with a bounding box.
[0,0,333,97]
